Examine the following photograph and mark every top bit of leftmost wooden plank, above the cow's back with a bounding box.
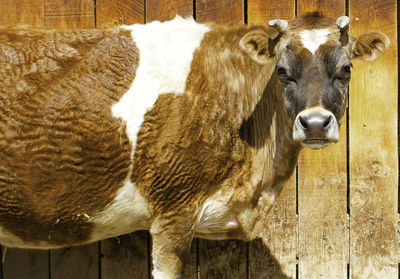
[0,0,44,27]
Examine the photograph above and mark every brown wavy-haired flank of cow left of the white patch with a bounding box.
[0,29,138,247]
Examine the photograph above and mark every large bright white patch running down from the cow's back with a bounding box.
[112,16,210,156]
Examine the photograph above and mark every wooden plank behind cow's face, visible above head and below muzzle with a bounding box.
[297,0,349,278]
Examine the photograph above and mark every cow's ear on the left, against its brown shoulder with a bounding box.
[239,28,279,64]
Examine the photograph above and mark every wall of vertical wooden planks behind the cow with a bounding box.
[0,0,400,279]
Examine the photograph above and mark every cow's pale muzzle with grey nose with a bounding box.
[293,107,339,149]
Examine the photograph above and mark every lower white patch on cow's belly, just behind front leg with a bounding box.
[89,171,150,241]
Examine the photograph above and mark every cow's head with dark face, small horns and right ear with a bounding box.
[269,12,390,148]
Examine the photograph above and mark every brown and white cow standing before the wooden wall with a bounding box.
[0,13,389,278]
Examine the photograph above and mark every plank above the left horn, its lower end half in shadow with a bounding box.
[247,3,297,278]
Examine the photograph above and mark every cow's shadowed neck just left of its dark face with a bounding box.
[240,71,301,188]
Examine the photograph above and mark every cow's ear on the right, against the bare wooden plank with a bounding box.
[352,31,390,61]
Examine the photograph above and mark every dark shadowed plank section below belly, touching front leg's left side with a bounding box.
[101,234,149,279]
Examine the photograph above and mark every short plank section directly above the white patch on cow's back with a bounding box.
[146,0,193,22]
